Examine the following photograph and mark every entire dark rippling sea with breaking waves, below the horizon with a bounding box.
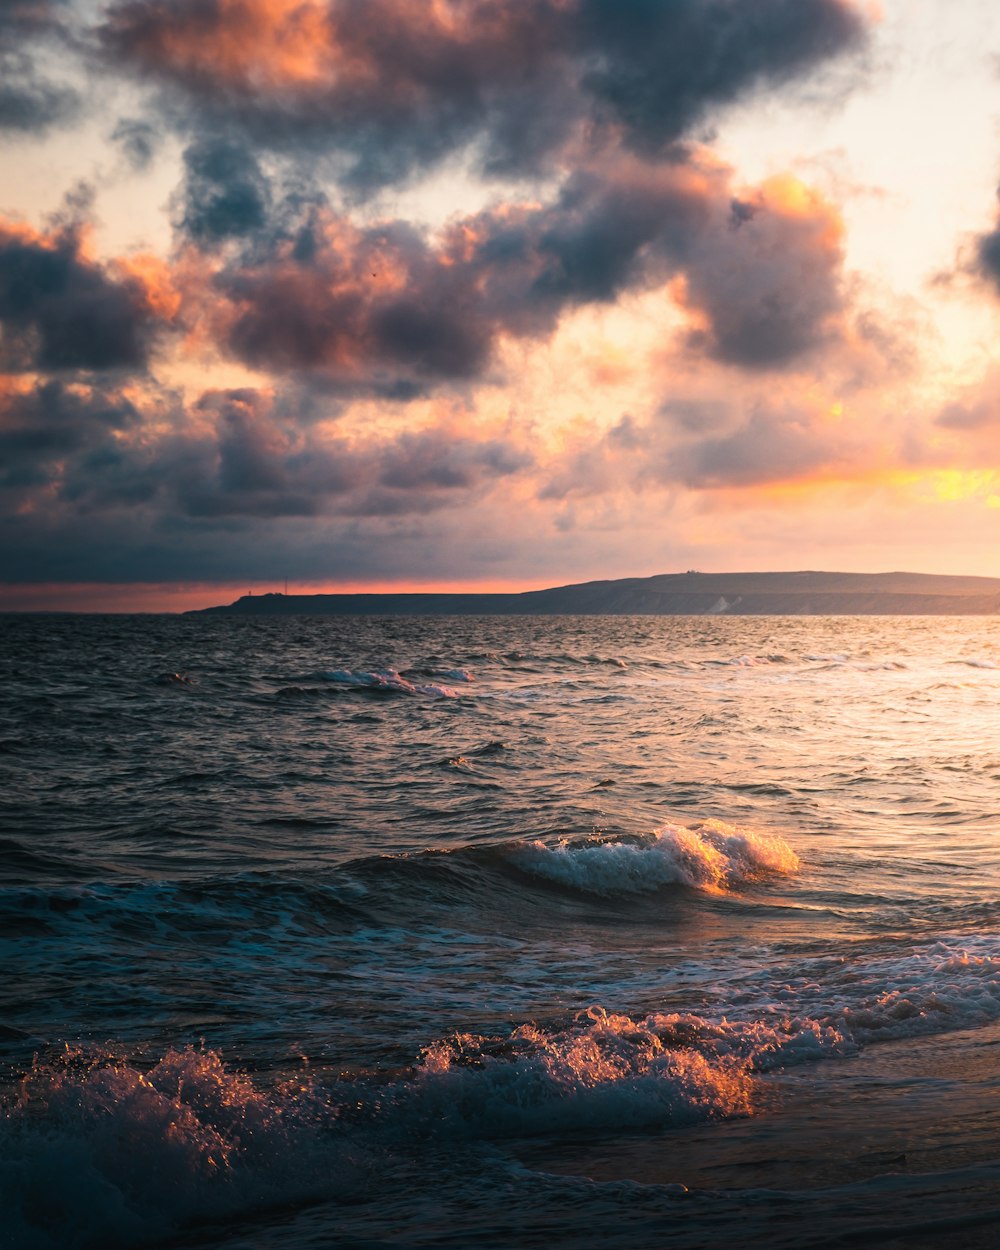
[0,618,1000,1250]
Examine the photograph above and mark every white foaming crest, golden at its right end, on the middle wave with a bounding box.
[514,820,799,894]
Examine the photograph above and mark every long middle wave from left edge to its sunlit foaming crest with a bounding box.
[0,820,799,944]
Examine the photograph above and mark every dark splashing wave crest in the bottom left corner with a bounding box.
[0,1049,353,1250]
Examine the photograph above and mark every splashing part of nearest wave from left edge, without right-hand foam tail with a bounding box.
[0,1006,830,1250]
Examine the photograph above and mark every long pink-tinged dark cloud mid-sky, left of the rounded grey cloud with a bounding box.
[206,178,670,380]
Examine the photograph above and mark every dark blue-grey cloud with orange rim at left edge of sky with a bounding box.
[0,221,176,371]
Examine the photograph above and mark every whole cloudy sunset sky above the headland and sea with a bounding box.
[0,0,1000,611]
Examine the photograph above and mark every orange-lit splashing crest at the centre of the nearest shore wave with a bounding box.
[413,1005,856,1136]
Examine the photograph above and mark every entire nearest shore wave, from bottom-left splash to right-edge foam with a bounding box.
[9,936,1000,1250]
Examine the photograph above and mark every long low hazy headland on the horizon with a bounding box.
[190,571,1000,616]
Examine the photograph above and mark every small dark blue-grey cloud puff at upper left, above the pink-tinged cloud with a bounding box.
[178,136,270,246]
